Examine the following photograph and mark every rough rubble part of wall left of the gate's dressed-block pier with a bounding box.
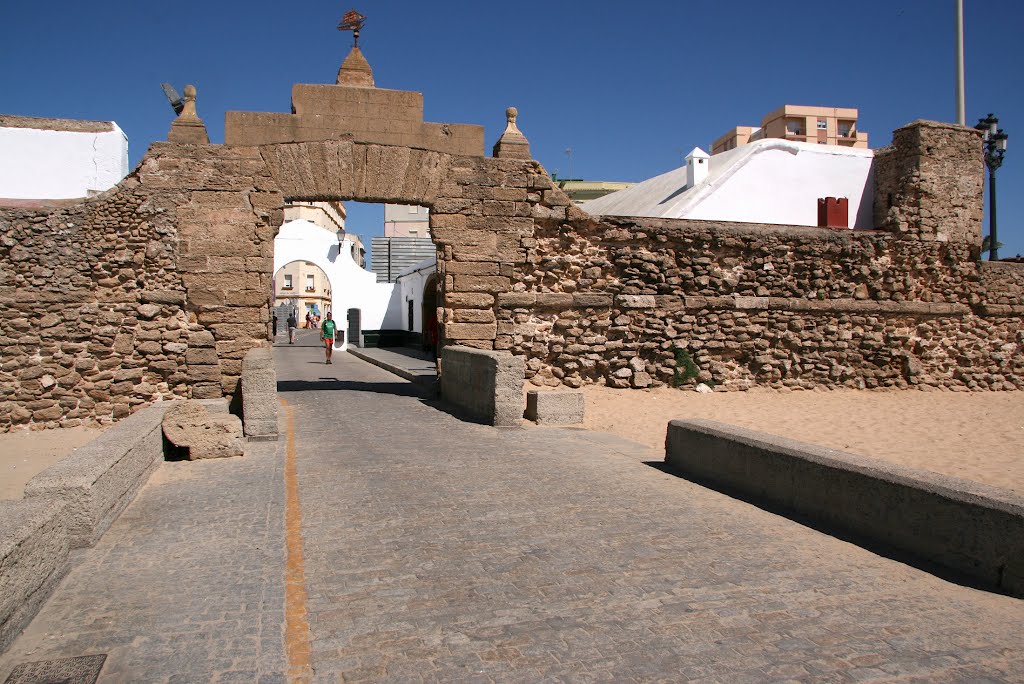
[0,178,188,430]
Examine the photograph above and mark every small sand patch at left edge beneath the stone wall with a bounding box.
[0,427,103,500]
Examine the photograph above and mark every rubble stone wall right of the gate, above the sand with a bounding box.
[496,219,1024,389]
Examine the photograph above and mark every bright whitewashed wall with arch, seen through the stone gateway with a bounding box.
[273,220,404,349]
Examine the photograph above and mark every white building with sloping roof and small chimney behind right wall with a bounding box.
[582,138,874,228]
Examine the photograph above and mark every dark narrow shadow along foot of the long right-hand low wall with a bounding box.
[644,461,1004,594]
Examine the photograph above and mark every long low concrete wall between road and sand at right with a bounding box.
[665,421,1024,597]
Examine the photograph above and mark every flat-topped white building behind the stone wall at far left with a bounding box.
[0,115,128,200]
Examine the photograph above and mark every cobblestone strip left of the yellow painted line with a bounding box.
[0,442,285,682]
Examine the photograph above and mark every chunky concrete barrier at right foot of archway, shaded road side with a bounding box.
[441,346,526,427]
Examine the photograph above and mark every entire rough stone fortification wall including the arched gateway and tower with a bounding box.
[0,53,1024,430]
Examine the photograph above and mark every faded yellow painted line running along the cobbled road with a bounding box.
[281,399,313,683]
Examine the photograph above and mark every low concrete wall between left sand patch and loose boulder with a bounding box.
[25,402,172,548]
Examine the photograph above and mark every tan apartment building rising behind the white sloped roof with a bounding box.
[711,104,867,155]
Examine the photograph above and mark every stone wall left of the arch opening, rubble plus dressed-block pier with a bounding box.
[0,144,282,430]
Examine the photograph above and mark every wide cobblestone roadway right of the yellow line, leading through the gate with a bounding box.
[279,350,1024,682]
